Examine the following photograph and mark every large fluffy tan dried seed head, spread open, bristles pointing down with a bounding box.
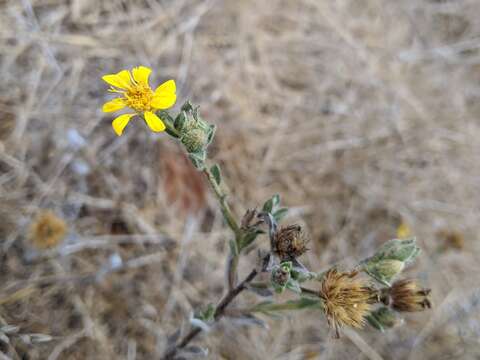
[319,269,378,337]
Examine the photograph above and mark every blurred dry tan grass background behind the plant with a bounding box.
[0,0,480,360]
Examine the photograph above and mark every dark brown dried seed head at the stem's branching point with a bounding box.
[272,225,308,261]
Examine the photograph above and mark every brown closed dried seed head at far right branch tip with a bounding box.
[389,279,432,312]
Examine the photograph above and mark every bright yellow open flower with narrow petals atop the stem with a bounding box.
[102,66,177,136]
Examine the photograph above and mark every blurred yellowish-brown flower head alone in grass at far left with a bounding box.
[29,210,67,249]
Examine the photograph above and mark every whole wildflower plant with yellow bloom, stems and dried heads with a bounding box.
[103,66,432,359]
